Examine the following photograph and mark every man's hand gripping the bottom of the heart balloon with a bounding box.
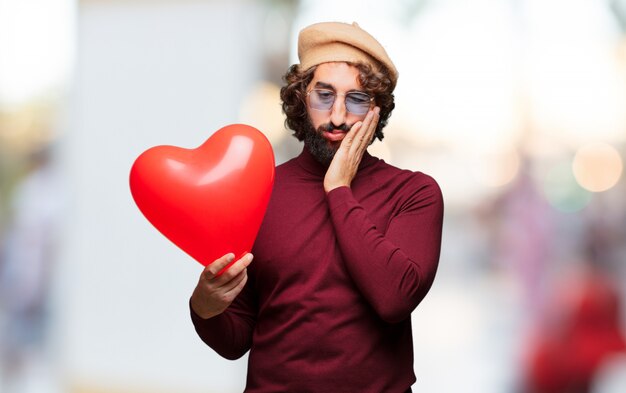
[191,254,252,319]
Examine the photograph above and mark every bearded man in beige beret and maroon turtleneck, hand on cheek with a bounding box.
[190,23,443,393]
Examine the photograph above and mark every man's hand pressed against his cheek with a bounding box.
[324,107,380,194]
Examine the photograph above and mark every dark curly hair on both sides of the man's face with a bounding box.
[280,63,395,142]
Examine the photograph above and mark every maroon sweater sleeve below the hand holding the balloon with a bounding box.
[189,274,257,360]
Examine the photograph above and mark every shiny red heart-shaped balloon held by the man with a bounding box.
[130,124,274,266]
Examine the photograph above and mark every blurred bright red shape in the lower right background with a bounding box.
[525,273,626,393]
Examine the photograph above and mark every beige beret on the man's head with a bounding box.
[298,22,398,86]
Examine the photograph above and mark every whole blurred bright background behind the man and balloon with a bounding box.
[0,0,626,393]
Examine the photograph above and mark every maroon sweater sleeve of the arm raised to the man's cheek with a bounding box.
[327,177,443,323]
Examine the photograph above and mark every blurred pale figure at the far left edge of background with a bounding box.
[0,146,62,393]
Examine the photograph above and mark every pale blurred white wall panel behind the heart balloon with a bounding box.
[55,1,263,392]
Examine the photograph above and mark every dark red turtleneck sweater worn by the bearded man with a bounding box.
[191,149,443,393]
